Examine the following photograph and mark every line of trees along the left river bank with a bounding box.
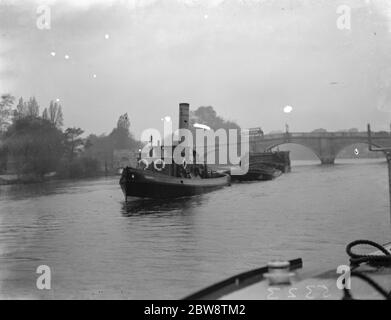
[0,94,140,179]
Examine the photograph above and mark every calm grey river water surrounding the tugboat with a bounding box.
[0,159,391,299]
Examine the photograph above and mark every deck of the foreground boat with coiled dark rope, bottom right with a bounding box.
[185,240,391,300]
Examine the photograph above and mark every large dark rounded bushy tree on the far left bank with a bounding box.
[4,116,64,177]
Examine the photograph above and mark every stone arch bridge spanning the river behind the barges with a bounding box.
[249,130,391,164]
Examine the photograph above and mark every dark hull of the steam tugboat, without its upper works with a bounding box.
[120,167,230,199]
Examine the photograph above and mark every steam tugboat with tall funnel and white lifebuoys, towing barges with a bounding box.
[120,103,231,200]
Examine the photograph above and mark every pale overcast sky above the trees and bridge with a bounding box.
[0,0,391,136]
